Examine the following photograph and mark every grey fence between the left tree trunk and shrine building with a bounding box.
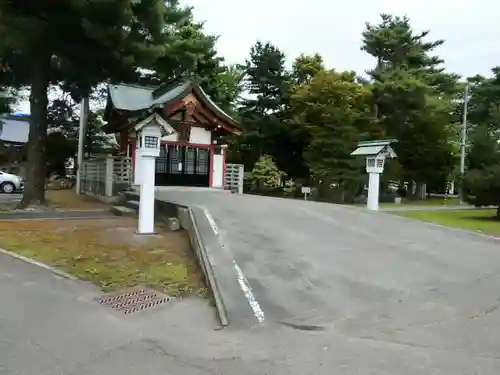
[79,156,132,197]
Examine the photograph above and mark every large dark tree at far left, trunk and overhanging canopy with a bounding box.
[0,0,169,207]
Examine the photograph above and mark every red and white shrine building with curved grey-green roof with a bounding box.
[104,79,241,188]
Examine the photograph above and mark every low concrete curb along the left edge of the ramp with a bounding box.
[120,192,229,328]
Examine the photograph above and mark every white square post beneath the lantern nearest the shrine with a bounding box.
[136,155,155,234]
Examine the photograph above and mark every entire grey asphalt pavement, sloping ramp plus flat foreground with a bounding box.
[0,190,500,375]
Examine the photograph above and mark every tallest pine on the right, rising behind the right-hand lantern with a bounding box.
[362,14,457,197]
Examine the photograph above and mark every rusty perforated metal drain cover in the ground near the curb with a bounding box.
[98,287,173,314]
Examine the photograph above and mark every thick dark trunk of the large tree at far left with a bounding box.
[18,56,50,208]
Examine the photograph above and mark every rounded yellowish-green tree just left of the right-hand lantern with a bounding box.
[291,71,370,202]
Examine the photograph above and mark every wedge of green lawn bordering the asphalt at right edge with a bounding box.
[393,209,500,236]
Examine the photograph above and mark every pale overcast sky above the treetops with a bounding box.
[184,0,500,76]
